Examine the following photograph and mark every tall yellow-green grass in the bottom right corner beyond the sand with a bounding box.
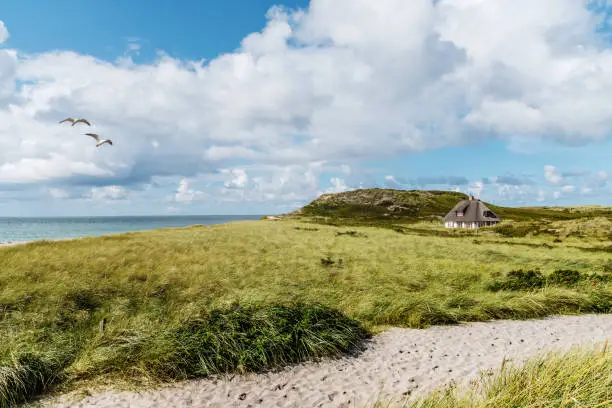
[377,342,612,408]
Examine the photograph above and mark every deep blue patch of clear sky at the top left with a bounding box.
[1,0,308,62]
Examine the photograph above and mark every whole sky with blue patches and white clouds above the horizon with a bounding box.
[0,0,612,216]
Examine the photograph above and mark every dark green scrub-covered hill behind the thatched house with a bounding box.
[290,188,612,222]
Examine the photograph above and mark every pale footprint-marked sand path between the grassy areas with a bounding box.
[44,315,612,408]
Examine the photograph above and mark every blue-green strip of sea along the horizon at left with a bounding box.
[0,215,263,243]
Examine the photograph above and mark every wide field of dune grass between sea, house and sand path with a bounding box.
[0,221,612,407]
